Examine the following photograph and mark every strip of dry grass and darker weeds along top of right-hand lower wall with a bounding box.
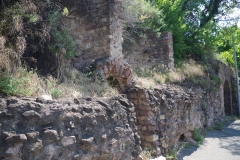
[134,60,221,93]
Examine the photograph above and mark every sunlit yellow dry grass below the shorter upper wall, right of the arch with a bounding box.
[135,61,206,88]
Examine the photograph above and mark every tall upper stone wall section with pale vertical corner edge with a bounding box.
[63,0,122,69]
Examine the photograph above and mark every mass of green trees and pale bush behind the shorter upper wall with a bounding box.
[124,0,240,64]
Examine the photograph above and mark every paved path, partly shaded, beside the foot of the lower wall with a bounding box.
[178,120,240,160]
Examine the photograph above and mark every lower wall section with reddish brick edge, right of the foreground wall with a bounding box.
[127,85,224,153]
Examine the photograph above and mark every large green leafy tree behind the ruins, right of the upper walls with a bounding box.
[151,0,238,62]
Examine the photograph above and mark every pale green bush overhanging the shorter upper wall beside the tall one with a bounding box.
[123,0,164,49]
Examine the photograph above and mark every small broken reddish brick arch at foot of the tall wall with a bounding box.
[97,58,133,91]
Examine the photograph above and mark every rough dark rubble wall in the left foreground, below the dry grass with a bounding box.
[0,97,141,160]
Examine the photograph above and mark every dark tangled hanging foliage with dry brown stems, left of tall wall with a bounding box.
[0,0,78,74]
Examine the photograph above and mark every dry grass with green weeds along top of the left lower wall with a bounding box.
[0,67,118,98]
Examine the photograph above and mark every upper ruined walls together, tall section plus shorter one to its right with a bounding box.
[64,0,174,69]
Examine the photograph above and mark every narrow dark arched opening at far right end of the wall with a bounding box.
[223,81,232,116]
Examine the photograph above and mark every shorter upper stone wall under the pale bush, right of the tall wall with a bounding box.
[123,32,174,69]
